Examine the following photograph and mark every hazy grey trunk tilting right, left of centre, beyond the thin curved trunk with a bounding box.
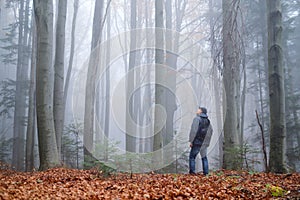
[83,0,104,166]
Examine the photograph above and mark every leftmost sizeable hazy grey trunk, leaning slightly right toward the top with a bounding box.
[12,0,29,170]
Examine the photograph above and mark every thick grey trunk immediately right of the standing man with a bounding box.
[222,0,241,169]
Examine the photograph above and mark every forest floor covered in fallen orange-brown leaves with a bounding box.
[0,168,300,199]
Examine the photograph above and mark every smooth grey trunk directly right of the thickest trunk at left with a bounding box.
[53,0,67,158]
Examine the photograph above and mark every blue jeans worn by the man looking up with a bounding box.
[189,145,208,175]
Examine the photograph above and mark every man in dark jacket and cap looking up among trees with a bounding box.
[189,107,213,175]
